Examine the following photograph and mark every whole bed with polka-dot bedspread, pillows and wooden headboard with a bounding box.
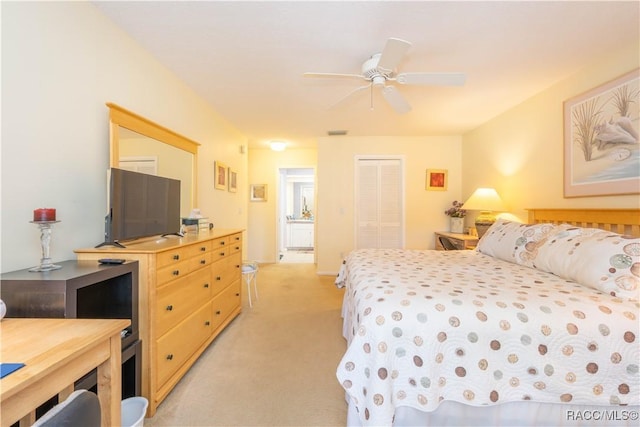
[336,209,640,426]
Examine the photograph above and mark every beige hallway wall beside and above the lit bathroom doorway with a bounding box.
[245,148,318,262]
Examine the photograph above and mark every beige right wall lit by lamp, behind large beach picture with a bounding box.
[462,40,640,226]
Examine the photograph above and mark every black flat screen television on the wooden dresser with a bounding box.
[99,168,180,246]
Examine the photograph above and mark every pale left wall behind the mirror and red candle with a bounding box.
[0,2,247,272]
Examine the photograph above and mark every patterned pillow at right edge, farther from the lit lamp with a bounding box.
[534,225,640,299]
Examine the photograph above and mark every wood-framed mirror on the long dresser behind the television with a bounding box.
[107,103,200,217]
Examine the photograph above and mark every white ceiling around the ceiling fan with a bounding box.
[95,0,640,147]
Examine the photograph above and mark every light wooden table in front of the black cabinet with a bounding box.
[0,319,130,427]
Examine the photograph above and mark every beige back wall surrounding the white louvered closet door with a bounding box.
[316,136,462,274]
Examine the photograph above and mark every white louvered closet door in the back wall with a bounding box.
[356,159,404,248]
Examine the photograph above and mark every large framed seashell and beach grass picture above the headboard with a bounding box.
[563,69,640,198]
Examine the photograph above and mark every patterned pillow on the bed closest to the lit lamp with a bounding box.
[478,218,557,267]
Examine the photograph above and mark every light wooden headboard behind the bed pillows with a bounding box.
[527,209,640,237]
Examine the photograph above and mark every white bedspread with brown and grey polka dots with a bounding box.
[336,249,640,425]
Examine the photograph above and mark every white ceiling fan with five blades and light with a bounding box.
[304,38,466,114]
